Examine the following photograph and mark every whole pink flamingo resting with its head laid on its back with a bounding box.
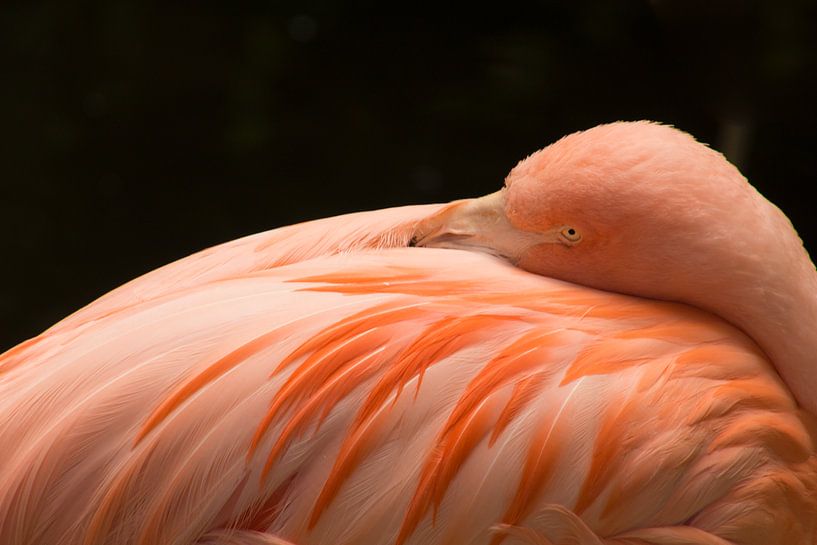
[0,122,817,545]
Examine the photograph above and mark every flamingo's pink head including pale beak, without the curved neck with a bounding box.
[415,122,780,306]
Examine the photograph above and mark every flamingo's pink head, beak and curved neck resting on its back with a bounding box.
[415,121,817,409]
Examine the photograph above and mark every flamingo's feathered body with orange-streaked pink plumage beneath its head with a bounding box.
[0,207,817,545]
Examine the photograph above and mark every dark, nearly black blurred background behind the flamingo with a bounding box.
[0,0,817,350]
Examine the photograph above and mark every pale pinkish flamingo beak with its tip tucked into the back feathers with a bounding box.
[410,189,553,263]
